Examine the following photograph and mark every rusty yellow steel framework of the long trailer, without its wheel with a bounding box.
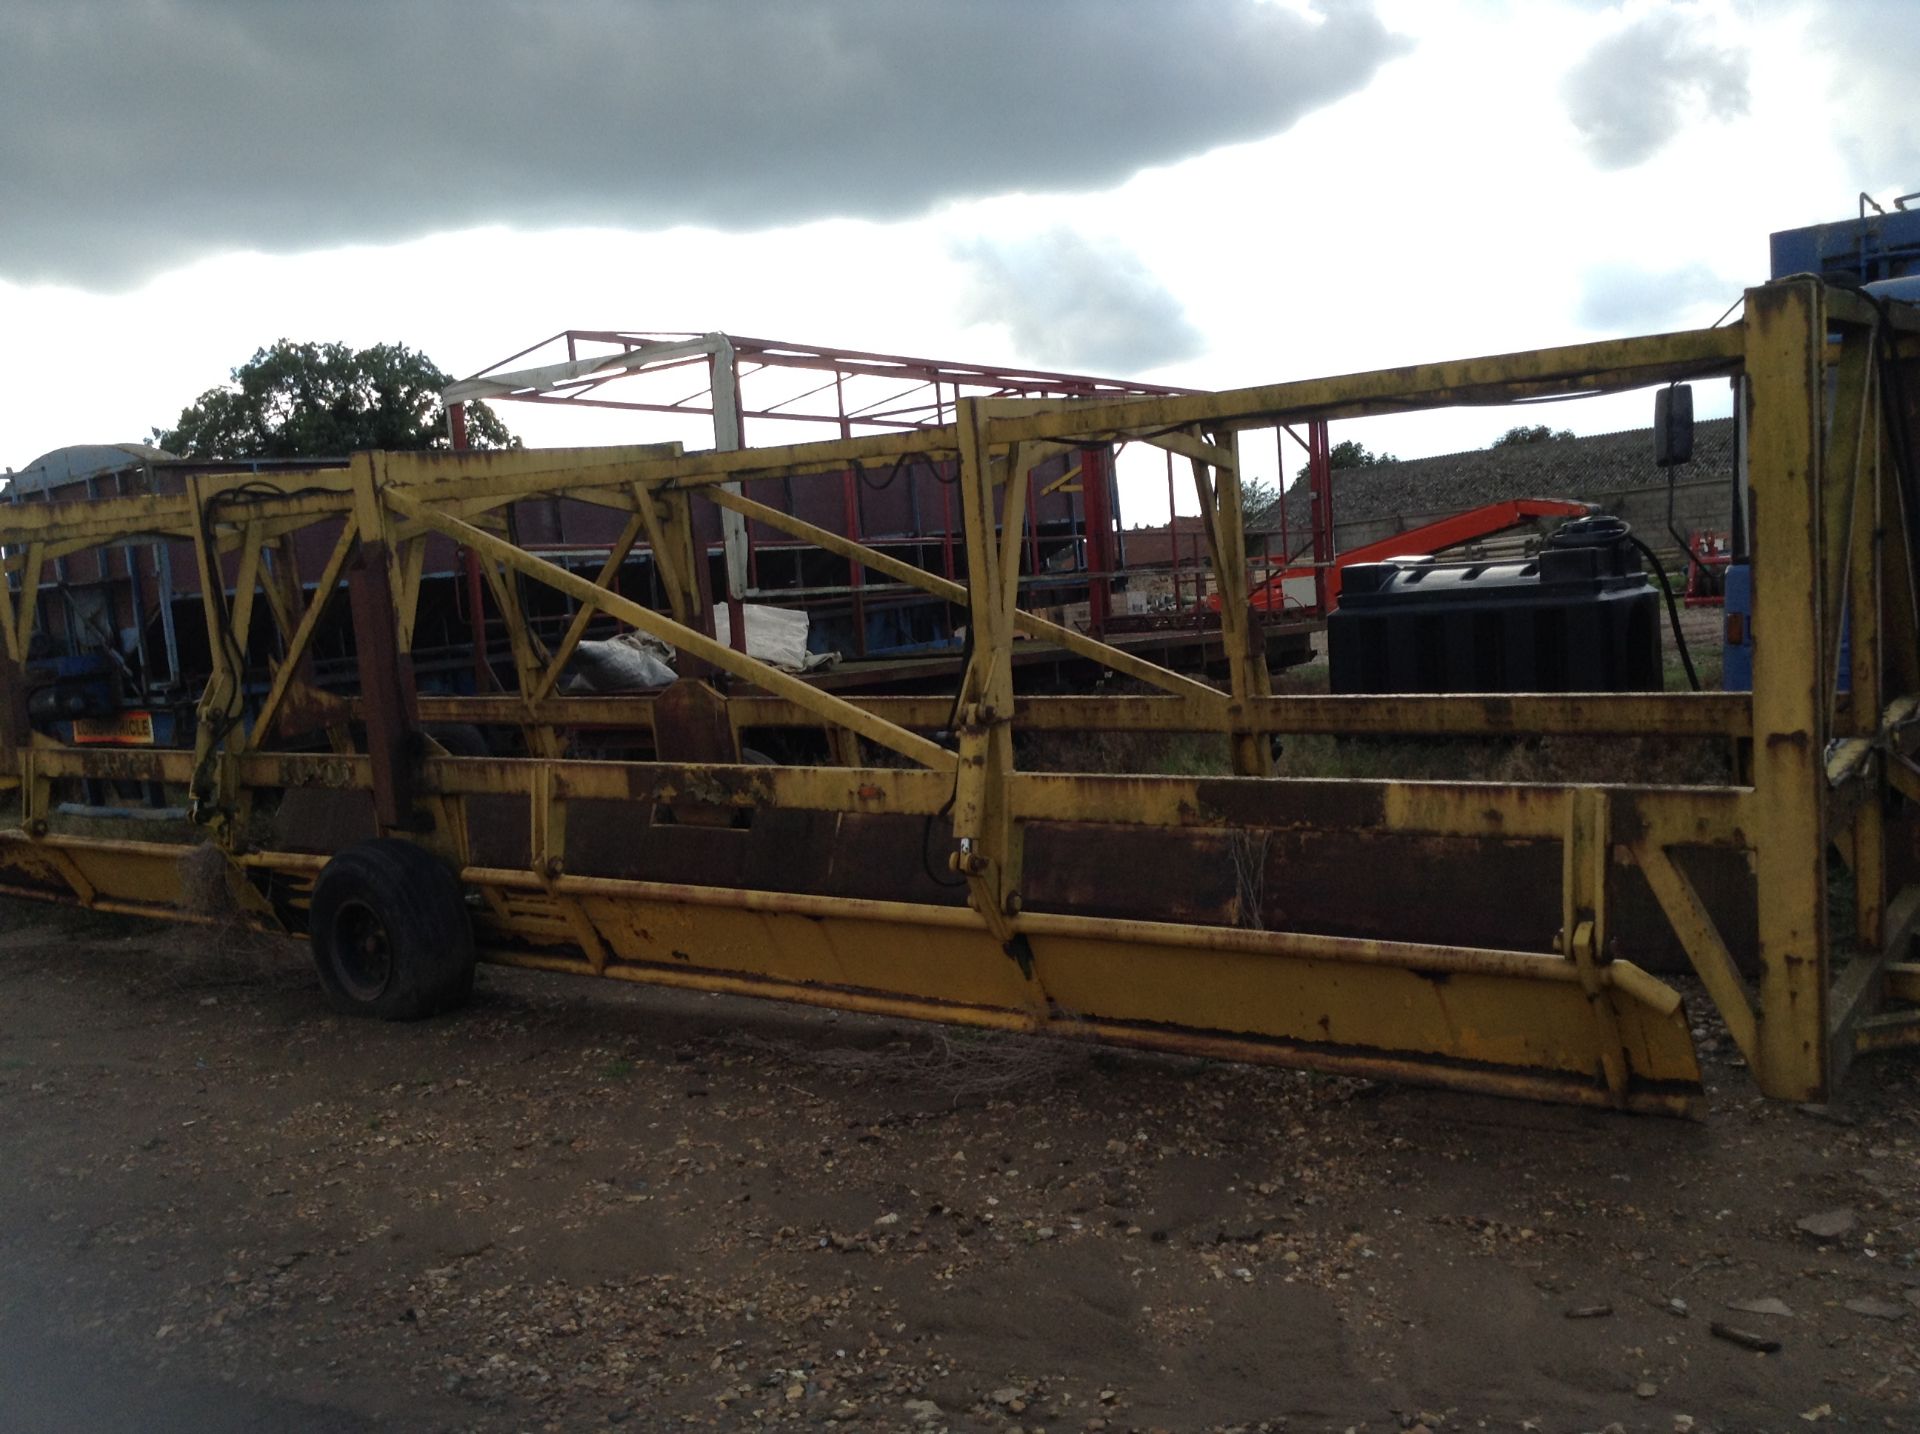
[0,280,1920,1111]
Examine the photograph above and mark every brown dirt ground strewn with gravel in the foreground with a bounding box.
[0,902,1920,1434]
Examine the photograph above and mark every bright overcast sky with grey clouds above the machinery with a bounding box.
[0,0,1920,520]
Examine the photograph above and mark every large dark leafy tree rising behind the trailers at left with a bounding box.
[154,338,520,459]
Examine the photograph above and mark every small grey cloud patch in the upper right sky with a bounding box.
[1563,10,1747,169]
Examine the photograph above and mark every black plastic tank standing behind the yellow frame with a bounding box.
[1327,518,1663,693]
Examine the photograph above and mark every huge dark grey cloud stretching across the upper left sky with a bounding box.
[0,0,1404,286]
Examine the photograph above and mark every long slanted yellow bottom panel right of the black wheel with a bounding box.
[456,870,1699,1113]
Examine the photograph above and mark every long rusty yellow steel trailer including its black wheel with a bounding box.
[0,278,1920,1113]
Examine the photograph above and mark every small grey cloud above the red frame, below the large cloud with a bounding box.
[954,228,1206,378]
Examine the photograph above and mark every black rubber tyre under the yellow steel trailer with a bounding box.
[307,837,474,1021]
